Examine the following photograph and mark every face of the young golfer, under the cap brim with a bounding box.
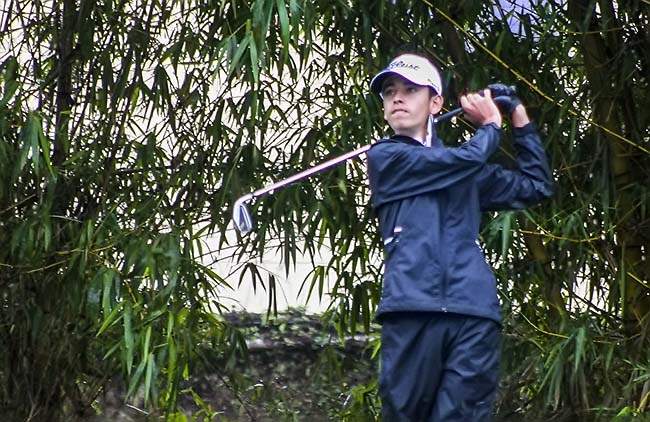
[381,75,443,139]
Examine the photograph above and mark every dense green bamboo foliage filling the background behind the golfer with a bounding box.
[0,0,650,420]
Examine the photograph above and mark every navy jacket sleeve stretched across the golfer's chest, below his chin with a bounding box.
[367,124,501,207]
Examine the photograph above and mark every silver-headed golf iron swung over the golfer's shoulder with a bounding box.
[232,87,515,234]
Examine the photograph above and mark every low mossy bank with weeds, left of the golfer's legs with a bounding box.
[170,310,377,421]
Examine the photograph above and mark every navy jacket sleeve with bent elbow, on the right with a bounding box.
[478,122,554,211]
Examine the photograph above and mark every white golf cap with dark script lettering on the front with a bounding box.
[370,54,442,95]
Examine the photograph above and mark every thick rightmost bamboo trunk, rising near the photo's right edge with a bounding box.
[569,0,650,335]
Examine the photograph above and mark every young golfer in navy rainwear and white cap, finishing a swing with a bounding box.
[367,54,553,422]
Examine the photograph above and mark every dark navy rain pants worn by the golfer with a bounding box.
[379,312,501,422]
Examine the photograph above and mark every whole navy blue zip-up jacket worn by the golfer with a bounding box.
[367,123,553,322]
